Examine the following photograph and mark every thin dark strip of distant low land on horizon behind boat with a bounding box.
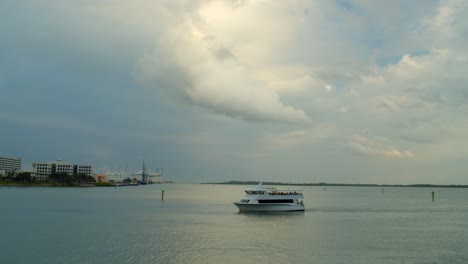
[201,181,468,188]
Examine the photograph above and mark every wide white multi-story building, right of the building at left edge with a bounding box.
[31,160,94,180]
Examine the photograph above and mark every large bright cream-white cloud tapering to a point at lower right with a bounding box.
[132,2,311,124]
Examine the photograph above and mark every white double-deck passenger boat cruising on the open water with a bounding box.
[234,183,304,212]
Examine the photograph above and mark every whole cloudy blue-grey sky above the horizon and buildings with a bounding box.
[0,0,468,184]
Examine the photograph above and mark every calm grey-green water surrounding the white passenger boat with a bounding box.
[0,184,468,264]
